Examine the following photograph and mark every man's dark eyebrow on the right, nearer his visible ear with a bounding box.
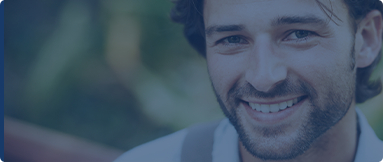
[271,15,328,26]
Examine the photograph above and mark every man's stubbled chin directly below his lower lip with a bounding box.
[236,113,314,160]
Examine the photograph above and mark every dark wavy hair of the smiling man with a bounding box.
[170,0,383,103]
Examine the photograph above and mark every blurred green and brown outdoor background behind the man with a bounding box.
[4,0,383,162]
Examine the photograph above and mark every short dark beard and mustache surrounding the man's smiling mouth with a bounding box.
[213,70,355,160]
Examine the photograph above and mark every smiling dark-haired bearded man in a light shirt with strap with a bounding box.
[117,0,383,162]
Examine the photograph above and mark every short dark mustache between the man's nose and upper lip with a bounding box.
[227,80,317,101]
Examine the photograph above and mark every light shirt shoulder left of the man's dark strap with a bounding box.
[114,129,188,162]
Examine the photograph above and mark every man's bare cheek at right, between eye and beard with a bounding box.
[290,47,355,101]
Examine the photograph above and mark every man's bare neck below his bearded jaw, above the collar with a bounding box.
[239,103,358,162]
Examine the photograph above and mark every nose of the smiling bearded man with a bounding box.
[245,38,287,92]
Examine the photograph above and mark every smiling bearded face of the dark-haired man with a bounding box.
[203,0,355,160]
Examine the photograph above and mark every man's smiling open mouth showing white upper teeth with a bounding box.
[245,96,307,113]
